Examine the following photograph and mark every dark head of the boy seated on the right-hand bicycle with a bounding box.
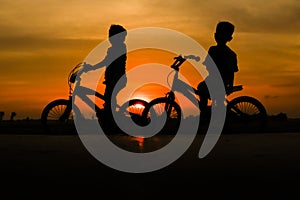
[215,21,234,44]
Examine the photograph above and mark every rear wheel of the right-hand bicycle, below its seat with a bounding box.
[225,96,267,132]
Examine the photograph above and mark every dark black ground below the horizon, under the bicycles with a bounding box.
[0,119,300,199]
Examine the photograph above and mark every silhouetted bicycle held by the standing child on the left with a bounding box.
[41,63,148,134]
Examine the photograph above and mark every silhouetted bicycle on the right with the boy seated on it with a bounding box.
[142,55,267,134]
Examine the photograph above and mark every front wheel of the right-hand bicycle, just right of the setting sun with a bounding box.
[143,97,181,135]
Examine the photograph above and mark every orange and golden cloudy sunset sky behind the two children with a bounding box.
[0,0,300,119]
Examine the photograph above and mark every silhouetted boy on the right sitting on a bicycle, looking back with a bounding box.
[197,21,238,115]
